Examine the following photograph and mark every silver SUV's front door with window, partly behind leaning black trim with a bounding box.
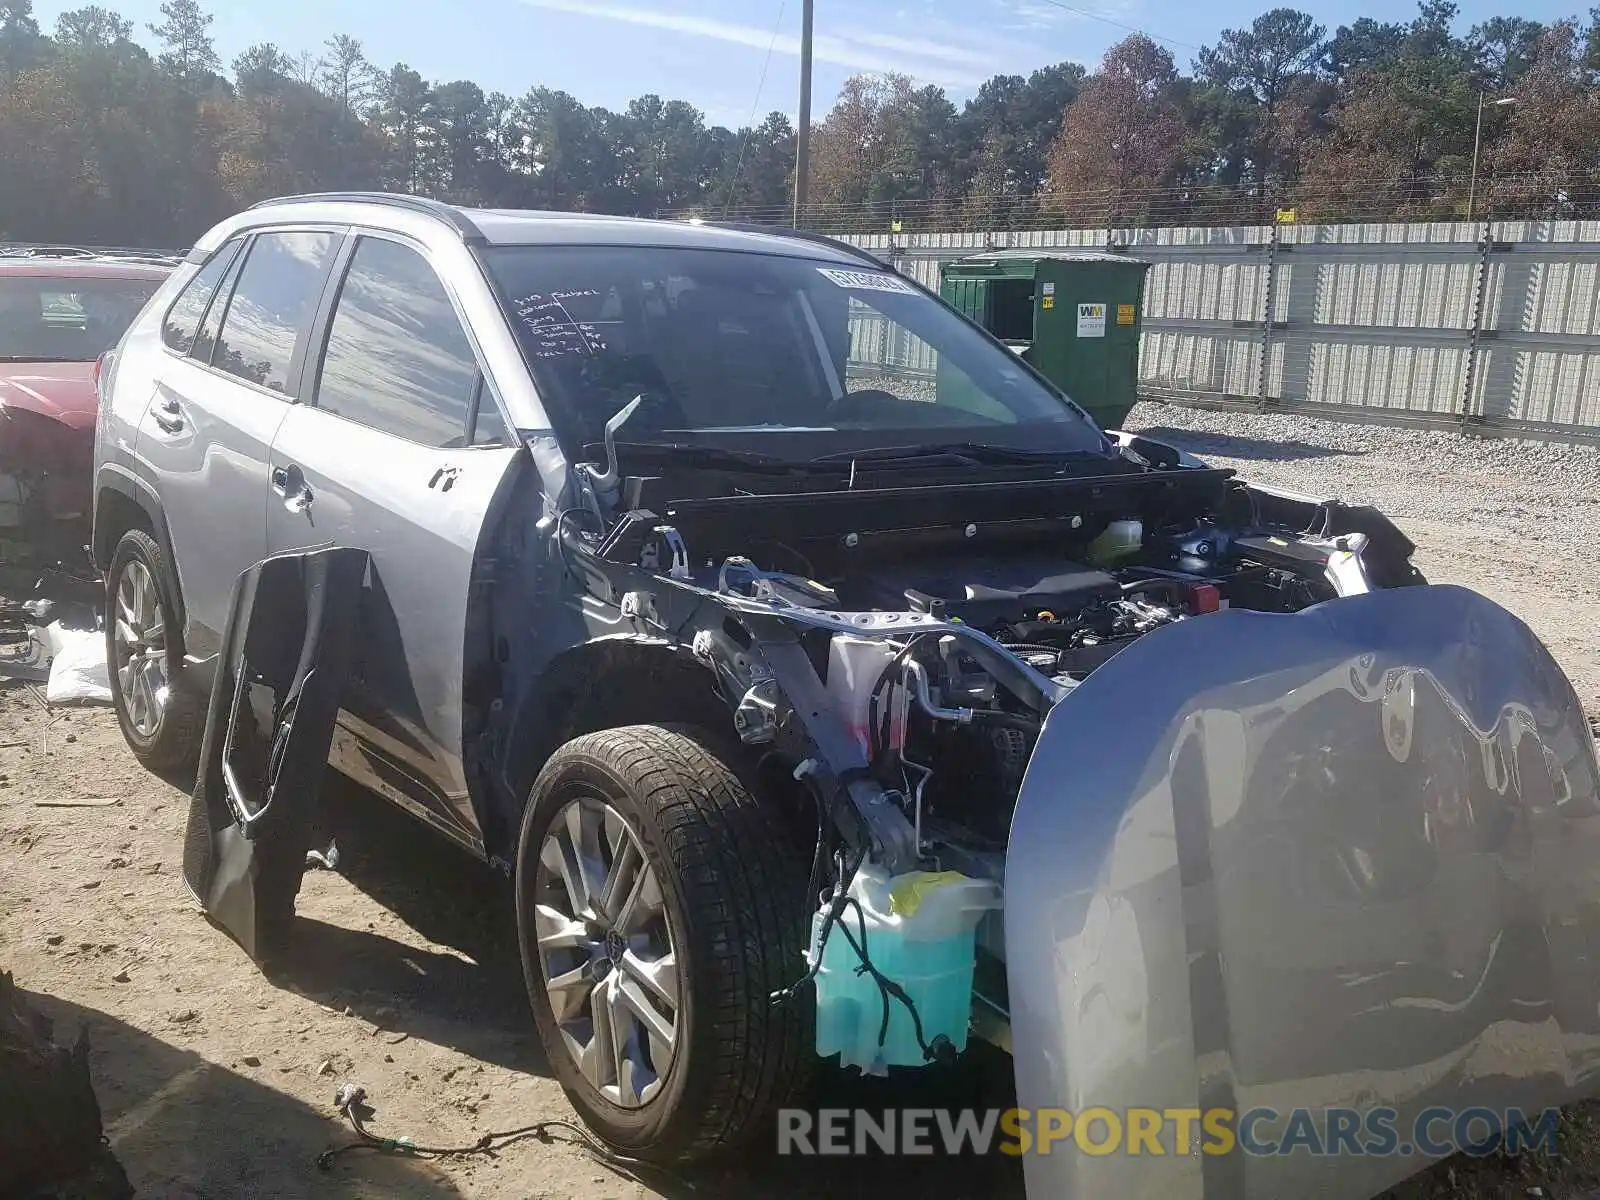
[267,235,520,850]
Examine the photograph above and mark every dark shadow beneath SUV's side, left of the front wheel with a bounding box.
[267,773,549,1075]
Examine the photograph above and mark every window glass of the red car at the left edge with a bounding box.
[0,275,160,363]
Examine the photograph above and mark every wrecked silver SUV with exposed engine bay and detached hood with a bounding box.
[93,195,1597,1195]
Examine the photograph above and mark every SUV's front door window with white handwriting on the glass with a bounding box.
[315,238,476,446]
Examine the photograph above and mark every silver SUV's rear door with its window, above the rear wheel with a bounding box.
[136,229,342,656]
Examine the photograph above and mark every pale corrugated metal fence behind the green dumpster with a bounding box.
[843,221,1600,440]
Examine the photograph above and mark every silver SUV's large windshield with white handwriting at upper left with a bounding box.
[488,246,1106,458]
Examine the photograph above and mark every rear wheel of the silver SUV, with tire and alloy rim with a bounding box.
[106,530,205,773]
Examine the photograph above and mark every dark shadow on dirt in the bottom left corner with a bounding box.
[24,992,461,1200]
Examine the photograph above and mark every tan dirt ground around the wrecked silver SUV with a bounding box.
[0,499,1600,1200]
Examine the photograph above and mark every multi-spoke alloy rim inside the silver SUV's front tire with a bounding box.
[533,795,682,1109]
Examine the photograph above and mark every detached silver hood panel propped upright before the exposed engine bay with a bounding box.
[1005,587,1600,1200]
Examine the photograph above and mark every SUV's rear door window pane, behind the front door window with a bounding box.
[211,232,334,400]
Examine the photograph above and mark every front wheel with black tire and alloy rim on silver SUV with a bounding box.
[517,725,813,1162]
